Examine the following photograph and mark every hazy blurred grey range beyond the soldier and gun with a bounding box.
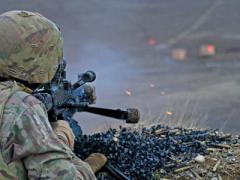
[0,0,240,133]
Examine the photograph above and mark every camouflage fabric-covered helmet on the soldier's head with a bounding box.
[0,11,63,83]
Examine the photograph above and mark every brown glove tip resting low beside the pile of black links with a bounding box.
[84,153,107,173]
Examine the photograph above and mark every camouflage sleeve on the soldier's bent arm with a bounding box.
[14,97,95,180]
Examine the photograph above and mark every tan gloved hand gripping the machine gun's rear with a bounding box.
[51,120,75,150]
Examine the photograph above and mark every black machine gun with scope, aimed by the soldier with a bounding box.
[33,60,140,136]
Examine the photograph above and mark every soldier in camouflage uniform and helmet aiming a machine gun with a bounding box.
[0,11,106,180]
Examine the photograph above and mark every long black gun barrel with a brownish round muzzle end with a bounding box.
[65,104,140,123]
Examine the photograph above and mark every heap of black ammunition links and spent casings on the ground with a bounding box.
[75,125,239,179]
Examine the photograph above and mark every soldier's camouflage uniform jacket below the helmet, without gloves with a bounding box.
[0,81,95,180]
